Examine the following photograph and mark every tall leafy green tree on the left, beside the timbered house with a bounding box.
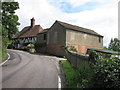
[2,2,20,40]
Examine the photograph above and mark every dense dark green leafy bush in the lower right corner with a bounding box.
[93,58,120,88]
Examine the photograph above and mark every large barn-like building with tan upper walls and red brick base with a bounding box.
[37,21,103,55]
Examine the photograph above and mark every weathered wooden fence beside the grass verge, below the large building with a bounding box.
[66,51,89,68]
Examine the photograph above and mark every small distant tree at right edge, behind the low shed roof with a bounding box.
[108,38,120,52]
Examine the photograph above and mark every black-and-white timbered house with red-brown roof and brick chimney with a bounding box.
[12,18,44,49]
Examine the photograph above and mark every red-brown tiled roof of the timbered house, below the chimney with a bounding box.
[13,25,44,38]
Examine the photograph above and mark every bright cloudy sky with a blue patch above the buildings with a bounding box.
[15,0,119,46]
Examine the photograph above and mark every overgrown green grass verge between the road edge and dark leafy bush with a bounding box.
[60,60,93,88]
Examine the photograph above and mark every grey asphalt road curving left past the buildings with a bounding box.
[2,50,59,88]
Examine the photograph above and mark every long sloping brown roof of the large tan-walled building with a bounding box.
[56,20,103,37]
